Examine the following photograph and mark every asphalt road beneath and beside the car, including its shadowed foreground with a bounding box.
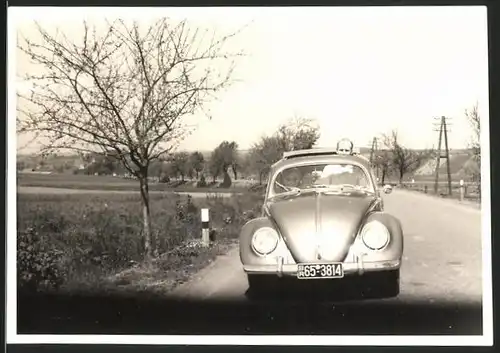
[18,190,482,335]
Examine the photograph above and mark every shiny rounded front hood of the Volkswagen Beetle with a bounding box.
[266,192,376,263]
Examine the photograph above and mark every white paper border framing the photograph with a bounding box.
[6,6,493,346]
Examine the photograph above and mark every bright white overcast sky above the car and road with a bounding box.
[9,6,488,151]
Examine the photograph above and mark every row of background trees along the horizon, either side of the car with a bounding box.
[146,117,435,188]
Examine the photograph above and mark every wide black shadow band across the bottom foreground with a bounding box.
[17,295,482,335]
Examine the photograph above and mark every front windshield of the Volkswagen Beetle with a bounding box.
[273,163,373,194]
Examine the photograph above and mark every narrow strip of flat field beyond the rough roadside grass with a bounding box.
[17,173,254,192]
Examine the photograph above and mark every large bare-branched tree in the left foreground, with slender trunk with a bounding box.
[17,18,245,260]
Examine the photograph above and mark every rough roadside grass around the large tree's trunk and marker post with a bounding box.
[17,192,263,296]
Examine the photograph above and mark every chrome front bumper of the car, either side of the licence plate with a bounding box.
[243,257,401,277]
